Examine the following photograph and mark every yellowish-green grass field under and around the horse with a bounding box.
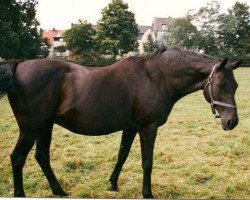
[0,68,250,199]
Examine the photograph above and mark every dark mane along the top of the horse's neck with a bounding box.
[125,47,221,63]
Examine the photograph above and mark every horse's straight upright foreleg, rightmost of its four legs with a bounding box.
[139,126,157,198]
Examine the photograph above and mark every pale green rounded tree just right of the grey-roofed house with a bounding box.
[166,17,199,49]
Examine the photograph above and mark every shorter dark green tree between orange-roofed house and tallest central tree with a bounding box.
[63,20,96,58]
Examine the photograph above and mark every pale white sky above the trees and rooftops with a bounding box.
[37,0,250,30]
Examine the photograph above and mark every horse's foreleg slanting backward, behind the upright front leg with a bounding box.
[109,129,137,191]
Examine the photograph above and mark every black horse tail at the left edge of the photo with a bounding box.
[0,62,18,98]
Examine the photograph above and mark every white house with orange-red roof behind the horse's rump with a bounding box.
[41,28,69,58]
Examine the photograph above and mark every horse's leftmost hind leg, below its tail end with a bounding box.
[10,130,35,197]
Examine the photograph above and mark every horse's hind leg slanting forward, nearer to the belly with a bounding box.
[35,124,68,196]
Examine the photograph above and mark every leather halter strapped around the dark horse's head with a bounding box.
[203,64,237,118]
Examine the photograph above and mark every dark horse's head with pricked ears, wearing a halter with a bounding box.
[204,58,242,130]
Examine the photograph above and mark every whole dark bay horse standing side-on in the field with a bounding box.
[0,48,241,198]
